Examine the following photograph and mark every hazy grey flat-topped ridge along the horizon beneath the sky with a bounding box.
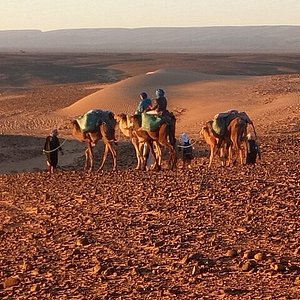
[0,26,300,53]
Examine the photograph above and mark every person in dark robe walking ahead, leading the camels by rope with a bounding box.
[43,129,64,174]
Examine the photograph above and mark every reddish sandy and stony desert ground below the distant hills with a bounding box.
[0,53,300,299]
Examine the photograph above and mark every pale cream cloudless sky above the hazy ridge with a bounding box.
[0,0,300,31]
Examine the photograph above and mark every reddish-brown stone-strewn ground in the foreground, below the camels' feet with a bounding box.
[0,133,300,299]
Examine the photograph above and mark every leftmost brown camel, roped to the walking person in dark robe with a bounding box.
[72,111,117,171]
